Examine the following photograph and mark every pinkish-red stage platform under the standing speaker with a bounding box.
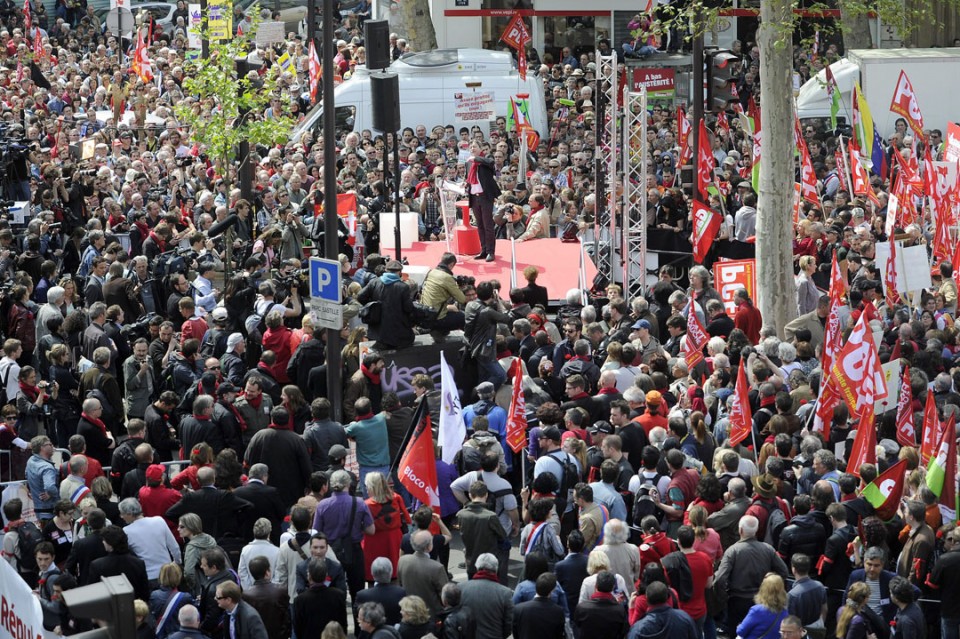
[387,238,597,300]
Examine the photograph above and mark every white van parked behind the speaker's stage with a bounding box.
[291,49,548,140]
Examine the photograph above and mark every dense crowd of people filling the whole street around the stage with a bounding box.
[0,0,960,639]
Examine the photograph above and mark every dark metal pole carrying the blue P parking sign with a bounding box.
[320,0,343,421]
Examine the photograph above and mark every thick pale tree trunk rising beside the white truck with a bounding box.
[756,0,797,339]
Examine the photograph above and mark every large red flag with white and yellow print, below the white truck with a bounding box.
[832,312,887,418]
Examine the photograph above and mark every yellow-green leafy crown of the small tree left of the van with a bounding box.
[175,12,296,171]
